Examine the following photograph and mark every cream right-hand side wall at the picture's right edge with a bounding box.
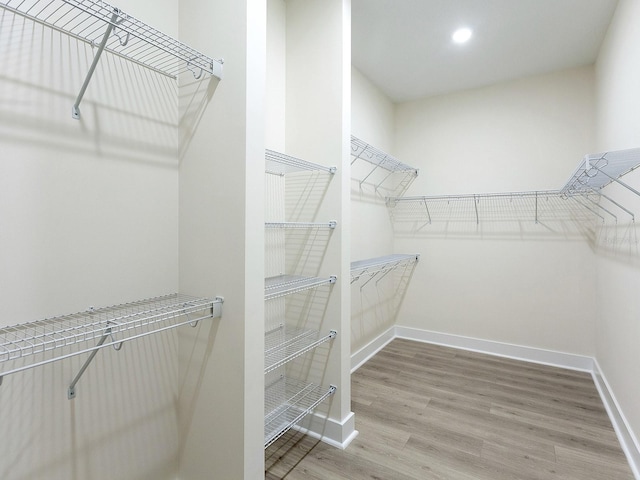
[596,0,640,461]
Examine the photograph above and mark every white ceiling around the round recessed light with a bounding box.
[351,0,617,102]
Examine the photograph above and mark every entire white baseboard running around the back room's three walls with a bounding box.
[351,325,640,480]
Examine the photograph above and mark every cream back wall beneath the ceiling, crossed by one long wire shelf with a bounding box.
[394,68,596,355]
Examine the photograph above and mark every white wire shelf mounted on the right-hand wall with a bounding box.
[561,148,640,193]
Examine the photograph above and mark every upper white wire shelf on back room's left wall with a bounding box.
[351,135,418,196]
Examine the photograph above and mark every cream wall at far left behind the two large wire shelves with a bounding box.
[0,0,178,480]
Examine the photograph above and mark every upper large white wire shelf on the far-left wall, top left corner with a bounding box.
[0,0,222,78]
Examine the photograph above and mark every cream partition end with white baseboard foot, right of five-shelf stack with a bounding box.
[286,0,355,446]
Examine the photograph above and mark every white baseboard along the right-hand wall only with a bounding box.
[591,360,640,480]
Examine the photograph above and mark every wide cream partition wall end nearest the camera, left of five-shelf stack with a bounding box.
[179,0,266,480]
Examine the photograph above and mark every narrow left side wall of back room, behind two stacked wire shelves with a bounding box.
[351,67,399,352]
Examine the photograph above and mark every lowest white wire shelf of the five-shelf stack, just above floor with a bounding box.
[264,377,337,449]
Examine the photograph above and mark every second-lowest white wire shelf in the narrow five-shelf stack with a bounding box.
[264,325,338,374]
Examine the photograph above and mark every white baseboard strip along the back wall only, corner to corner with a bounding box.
[395,326,593,372]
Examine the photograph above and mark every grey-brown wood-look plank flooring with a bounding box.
[265,340,633,480]
